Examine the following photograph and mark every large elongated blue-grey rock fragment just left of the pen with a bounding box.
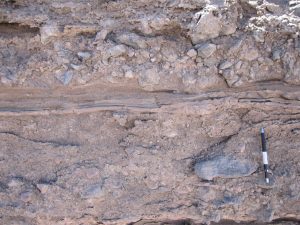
[195,156,257,180]
